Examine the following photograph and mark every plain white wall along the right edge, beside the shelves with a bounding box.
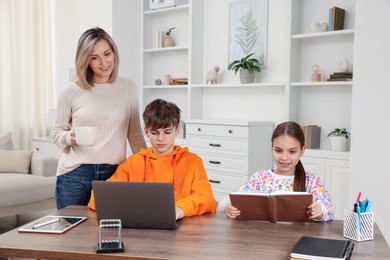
[350,0,390,245]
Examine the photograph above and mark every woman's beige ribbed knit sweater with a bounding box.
[50,77,146,175]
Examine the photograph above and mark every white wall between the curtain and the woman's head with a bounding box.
[51,0,112,106]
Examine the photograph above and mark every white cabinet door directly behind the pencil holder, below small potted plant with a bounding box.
[325,159,353,219]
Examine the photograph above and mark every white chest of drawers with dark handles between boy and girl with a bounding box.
[186,120,274,201]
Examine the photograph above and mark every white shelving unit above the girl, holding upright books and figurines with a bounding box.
[286,0,355,151]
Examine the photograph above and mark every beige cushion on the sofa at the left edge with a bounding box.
[0,150,32,173]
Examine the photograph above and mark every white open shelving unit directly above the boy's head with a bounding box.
[141,0,203,119]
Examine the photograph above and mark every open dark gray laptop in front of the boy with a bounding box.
[92,181,178,229]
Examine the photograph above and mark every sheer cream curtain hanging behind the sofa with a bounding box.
[0,0,53,150]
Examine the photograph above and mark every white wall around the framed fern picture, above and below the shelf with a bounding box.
[203,0,289,121]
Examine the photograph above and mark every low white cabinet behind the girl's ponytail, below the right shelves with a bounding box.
[301,150,352,219]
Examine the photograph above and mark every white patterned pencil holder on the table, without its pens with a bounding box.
[344,209,374,242]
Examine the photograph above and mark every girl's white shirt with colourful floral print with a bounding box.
[240,170,334,221]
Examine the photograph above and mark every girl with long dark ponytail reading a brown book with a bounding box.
[222,121,333,221]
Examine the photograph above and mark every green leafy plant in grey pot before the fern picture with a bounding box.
[228,53,261,83]
